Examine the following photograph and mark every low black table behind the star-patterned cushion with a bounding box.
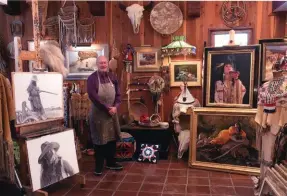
[121,125,172,159]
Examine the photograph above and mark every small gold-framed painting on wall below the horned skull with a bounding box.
[134,46,161,72]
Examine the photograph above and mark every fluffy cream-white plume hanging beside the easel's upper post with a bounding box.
[40,41,68,78]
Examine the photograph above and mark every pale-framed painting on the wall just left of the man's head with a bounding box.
[65,44,109,80]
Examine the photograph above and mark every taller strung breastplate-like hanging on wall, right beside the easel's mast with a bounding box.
[58,1,78,49]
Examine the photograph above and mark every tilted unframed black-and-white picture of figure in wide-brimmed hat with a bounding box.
[26,129,79,191]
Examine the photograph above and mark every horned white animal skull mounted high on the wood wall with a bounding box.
[119,1,153,34]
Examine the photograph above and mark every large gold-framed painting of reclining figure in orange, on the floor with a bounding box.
[189,107,260,174]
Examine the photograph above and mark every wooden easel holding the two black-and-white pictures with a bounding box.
[14,0,86,196]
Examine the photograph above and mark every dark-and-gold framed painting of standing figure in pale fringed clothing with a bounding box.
[203,45,260,108]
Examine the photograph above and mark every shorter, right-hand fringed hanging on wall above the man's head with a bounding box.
[78,17,95,43]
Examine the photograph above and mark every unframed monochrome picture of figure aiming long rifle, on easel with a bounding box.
[12,72,64,126]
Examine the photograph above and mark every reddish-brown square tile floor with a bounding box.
[43,157,254,196]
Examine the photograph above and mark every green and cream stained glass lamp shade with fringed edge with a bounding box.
[161,36,196,57]
